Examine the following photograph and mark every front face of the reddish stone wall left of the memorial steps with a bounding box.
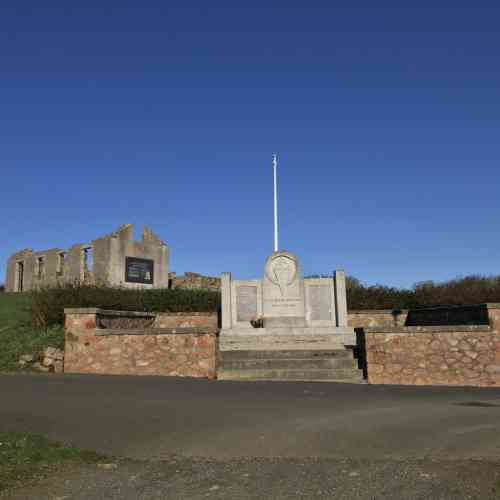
[64,313,217,378]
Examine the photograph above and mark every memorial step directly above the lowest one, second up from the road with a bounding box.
[219,355,358,370]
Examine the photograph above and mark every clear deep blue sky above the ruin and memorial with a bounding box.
[0,0,500,286]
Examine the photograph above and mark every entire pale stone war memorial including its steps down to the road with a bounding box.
[218,252,363,382]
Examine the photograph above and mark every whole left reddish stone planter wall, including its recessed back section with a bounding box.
[64,309,217,378]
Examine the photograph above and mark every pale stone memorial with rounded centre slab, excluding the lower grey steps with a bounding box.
[220,251,355,351]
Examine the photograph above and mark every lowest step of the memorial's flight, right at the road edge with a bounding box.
[217,368,363,383]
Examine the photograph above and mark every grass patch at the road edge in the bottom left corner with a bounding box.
[0,433,103,492]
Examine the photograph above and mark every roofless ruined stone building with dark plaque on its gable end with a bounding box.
[5,224,170,292]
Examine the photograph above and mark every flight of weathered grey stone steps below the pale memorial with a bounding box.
[217,349,363,383]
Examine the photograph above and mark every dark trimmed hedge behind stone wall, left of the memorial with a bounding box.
[31,284,220,328]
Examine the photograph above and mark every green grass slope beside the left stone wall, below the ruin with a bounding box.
[0,293,64,372]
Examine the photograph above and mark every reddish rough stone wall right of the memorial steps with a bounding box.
[365,324,500,386]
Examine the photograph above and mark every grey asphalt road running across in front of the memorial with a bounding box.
[0,375,500,460]
